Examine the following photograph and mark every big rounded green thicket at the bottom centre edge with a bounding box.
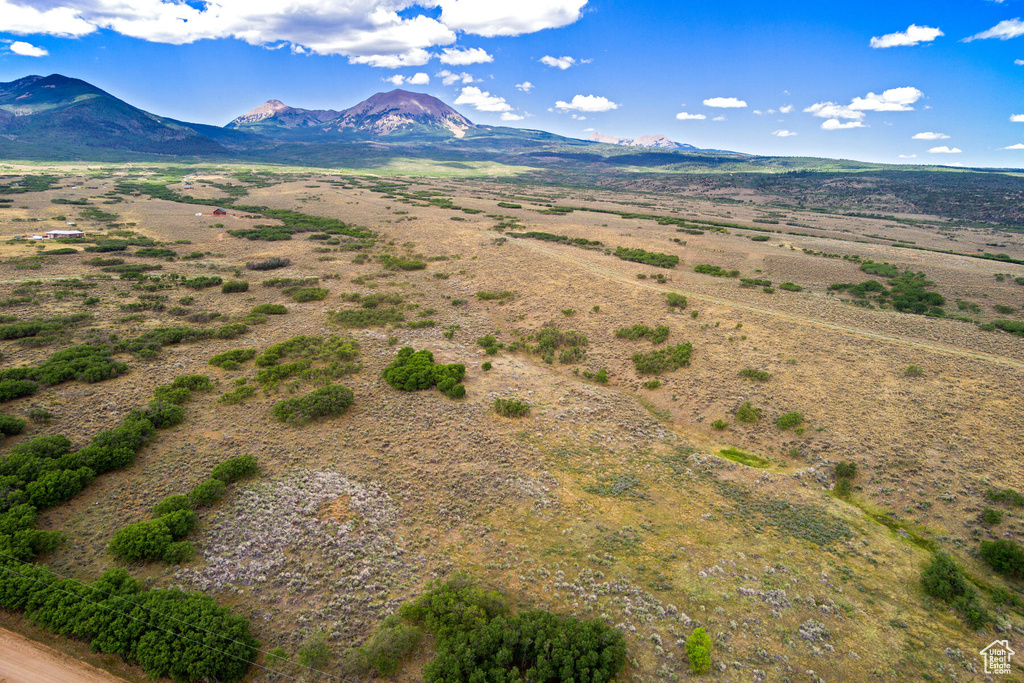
[346,574,627,683]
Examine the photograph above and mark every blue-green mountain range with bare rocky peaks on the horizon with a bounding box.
[0,74,770,167]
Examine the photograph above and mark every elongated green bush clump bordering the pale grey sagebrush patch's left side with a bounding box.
[109,456,259,564]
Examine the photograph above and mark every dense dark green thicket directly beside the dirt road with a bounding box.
[0,560,259,683]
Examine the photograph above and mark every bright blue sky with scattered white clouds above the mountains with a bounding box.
[0,0,1024,167]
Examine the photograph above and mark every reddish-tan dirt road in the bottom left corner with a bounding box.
[0,629,124,683]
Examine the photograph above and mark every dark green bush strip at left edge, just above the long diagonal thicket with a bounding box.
[0,344,128,402]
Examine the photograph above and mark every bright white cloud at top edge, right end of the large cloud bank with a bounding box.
[436,0,587,38]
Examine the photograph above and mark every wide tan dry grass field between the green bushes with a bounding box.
[0,165,1024,683]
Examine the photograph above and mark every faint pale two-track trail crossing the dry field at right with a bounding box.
[512,232,1024,370]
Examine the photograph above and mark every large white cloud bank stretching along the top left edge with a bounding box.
[0,0,587,64]
